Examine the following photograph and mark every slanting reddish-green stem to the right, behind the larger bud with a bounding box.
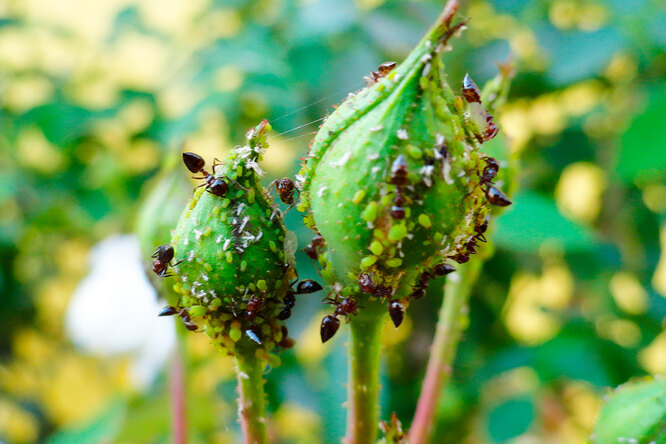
[409,258,483,444]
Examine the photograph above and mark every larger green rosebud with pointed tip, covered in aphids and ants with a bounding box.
[299,11,510,316]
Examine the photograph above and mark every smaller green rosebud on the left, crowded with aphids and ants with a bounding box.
[171,121,296,358]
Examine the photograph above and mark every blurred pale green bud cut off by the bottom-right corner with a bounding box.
[591,379,666,444]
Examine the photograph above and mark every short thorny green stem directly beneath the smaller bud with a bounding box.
[236,354,268,444]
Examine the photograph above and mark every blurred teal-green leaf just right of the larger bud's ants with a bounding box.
[493,191,595,252]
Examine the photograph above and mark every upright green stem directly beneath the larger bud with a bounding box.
[346,304,386,444]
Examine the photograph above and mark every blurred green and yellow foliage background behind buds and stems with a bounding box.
[0,0,666,443]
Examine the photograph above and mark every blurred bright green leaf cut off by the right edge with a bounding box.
[616,90,666,183]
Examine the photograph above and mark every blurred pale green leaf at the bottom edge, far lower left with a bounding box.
[45,400,126,444]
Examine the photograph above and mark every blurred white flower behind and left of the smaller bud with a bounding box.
[65,235,176,388]
